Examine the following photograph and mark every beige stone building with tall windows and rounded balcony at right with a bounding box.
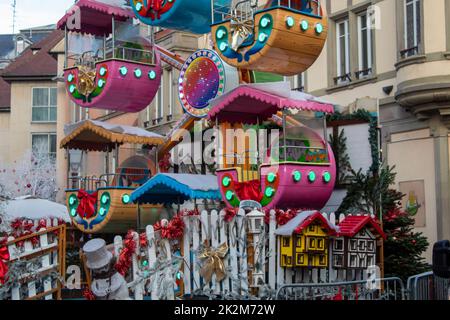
[292,0,450,261]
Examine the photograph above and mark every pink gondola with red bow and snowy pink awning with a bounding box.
[208,83,336,210]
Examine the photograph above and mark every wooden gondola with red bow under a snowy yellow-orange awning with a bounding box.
[61,120,164,233]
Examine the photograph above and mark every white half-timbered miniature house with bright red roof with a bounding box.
[332,216,385,269]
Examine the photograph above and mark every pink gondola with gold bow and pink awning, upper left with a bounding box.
[58,0,161,112]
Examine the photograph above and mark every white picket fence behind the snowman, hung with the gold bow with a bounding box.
[114,210,376,300]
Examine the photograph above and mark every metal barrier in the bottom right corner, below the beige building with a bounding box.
[407,271,450,300]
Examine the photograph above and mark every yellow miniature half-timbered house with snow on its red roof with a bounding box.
[275,211,336,268]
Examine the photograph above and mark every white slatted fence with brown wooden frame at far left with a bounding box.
[6,219,66,300]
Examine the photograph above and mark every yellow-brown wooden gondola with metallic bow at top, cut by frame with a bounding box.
[212,0,328,76]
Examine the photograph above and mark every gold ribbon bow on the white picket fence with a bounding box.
[199,243,228,283]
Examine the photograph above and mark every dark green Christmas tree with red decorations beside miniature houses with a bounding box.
[339,166,430,280]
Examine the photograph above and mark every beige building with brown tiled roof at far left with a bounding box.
[0,31,63,178]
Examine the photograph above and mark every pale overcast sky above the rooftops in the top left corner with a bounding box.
[0,0,74,34]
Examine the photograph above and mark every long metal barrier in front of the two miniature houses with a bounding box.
[276,277,405,300]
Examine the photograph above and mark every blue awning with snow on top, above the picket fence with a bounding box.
[131,173,222,204]
